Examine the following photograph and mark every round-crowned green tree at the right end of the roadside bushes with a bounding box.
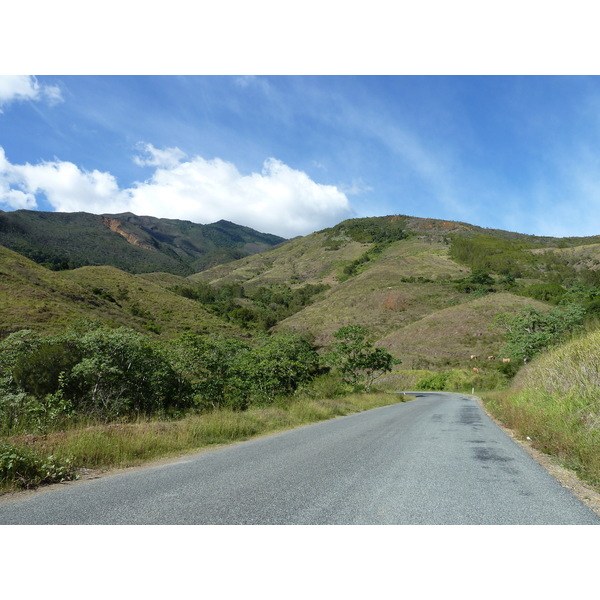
[326,325,400,390]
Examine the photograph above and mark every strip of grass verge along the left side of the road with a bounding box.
[0,393,411,494]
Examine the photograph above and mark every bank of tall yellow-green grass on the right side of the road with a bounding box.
[483,332,600,487]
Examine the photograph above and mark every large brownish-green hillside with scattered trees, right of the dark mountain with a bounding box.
[188,216,595,369]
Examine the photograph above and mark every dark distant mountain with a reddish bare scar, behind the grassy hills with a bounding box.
[0,210,285,276]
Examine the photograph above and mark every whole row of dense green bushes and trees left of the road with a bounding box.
[0,324,394,435]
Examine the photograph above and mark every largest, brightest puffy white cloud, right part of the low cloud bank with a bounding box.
[129,156,351,237]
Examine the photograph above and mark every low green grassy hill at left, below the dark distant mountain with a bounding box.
[0,246,244,337]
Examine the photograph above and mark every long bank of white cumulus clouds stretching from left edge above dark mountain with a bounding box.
[0,144,353,237]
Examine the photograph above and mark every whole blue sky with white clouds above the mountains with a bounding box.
[0,75,600,237]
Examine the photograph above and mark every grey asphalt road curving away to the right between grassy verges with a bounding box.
[0,393,600,525]
